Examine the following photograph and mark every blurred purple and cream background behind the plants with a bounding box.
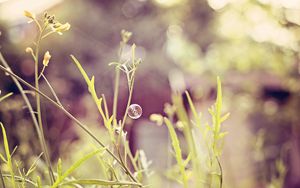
[0,0,300,188]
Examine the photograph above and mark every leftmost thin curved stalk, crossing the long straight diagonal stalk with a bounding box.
[0,52,54,184]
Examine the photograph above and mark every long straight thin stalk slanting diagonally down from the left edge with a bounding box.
[0,65,142,186]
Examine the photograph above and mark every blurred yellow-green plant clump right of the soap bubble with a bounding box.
[150,78,229,187]
